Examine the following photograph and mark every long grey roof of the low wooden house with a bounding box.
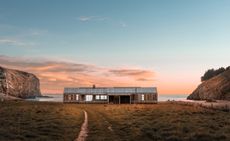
[64,87,157,94]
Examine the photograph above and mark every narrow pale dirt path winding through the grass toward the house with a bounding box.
[75,111,88,141]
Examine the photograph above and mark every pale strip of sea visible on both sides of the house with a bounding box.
[28,94,188,102]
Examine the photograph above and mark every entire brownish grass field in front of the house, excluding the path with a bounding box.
[0,102,230,141]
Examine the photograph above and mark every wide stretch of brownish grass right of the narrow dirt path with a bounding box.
[82,103,230,141]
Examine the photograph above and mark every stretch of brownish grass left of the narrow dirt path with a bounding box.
[0,101,83,141]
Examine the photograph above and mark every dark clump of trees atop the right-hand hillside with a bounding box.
[201,66,230,81]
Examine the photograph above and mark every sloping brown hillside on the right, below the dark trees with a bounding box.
[187,70,230,100]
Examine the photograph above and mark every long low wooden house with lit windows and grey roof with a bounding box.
[63,86,157,104]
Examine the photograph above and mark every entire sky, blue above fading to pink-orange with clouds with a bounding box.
[0,0,230,94]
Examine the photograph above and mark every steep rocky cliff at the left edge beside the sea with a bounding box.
[0,66,41,98]
